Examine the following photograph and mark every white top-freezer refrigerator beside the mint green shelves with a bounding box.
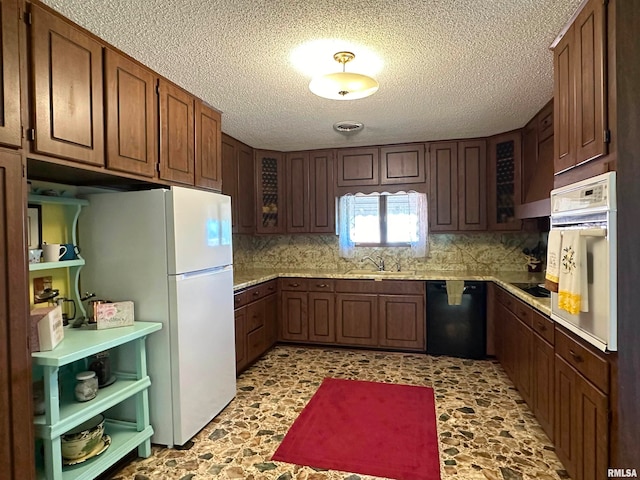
[78,187,236,446]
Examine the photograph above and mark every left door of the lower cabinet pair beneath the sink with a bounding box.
[336,293,378,347]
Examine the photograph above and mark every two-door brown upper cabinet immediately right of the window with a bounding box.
[429,140,487,232]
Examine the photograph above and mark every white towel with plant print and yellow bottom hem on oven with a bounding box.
[558,230,589,315]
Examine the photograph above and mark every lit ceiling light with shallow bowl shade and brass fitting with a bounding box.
[309,52,379,100]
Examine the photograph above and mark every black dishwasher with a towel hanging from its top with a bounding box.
[427,281,487,358]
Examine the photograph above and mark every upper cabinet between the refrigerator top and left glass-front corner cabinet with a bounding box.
[221,133,256,234]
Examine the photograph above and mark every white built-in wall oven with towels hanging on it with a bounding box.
[551,172,618,351]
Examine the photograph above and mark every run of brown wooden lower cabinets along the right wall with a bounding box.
[494,288,611,480]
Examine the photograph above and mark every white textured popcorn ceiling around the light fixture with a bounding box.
[40,0,580,151]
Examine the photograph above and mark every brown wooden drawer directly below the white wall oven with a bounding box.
[555,326,609,393]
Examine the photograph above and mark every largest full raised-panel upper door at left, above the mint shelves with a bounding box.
[31,4,104,165]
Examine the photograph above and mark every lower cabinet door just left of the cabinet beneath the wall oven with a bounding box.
[531,335,554,441]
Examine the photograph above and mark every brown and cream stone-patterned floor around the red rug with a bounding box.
[112,346,568,480]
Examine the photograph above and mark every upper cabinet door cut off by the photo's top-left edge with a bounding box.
[0,0,22,147]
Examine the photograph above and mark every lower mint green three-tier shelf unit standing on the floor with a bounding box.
[31,322,162,480]
